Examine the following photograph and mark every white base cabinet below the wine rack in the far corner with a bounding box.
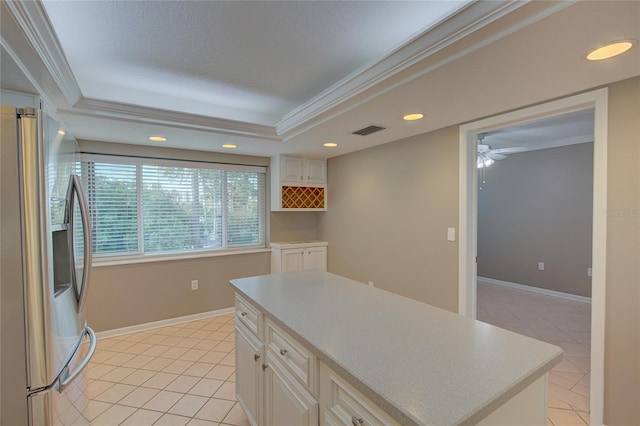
[271,241,327,274]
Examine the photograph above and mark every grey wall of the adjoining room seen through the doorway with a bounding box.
[478,143,593,297]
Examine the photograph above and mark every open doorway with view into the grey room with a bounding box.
[476,109,594,424]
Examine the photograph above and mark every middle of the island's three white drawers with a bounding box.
[265,320,318,396]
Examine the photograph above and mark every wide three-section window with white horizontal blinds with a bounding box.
[81,154,266,258]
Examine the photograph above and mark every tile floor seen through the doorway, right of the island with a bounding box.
[477,281,591,426]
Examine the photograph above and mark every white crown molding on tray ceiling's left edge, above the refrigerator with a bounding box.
[3,0,82,105]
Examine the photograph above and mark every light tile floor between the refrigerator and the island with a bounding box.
[87,314,249,426]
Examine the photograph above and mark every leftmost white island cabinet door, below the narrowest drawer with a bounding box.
[236,320,263,426]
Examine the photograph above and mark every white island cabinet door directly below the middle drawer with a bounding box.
[264,361,318,426]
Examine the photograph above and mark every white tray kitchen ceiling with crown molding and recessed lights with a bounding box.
[0,0,640,157]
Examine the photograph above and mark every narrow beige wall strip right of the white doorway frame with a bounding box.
[605,77,640,426]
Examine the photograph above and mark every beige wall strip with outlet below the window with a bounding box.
[87,252,270,331]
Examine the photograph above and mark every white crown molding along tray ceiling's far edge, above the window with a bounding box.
[65,98,282,142]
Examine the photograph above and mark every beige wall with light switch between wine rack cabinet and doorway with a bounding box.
[318,127,458,311]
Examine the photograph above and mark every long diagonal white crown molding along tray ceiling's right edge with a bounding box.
[276,0,578,140]
